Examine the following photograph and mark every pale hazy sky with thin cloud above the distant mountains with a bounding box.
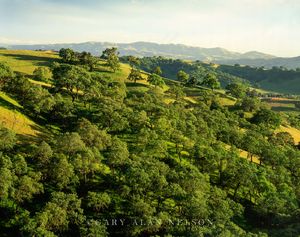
[0,0,300,57]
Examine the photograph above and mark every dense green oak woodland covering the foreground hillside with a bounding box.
[0,48,300,237]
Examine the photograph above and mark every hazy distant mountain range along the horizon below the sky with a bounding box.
[6,42,300,69]
